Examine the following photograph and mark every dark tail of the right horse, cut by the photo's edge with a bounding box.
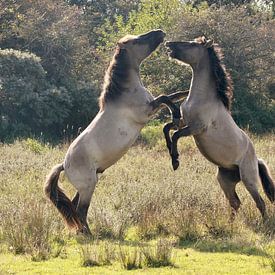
[258,159,275,202]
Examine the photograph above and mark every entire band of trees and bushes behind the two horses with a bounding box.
[0,0,275,141]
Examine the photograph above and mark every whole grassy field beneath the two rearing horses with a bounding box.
[0,128,275,274]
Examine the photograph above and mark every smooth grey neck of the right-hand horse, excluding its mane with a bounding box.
[189,62,217,102]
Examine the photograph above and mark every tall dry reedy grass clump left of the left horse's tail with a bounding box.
[0,198,58,261]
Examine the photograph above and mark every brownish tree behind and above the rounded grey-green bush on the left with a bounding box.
[0,0,101,141]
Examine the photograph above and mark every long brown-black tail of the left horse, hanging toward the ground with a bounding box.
[44,163,82,229]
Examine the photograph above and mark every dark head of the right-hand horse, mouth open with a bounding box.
[165,36,213,66]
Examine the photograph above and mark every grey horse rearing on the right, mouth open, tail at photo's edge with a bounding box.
[164,37,275,221]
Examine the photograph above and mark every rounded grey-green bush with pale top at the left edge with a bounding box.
[0,49,71,140]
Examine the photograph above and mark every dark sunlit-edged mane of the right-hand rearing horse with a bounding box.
[198,38,233,111]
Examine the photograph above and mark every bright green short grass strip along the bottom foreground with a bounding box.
[0,245,273,274]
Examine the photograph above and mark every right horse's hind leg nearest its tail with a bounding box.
[239,156,266,219]
